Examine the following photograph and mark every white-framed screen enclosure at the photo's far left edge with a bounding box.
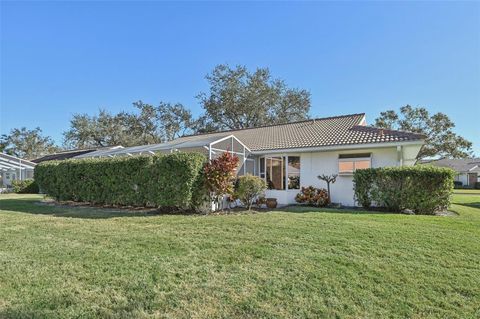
[0,153,36,188]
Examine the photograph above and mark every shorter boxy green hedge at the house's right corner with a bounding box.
[353,165,455,214]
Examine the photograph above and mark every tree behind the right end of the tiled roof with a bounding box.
[375,105,472,159]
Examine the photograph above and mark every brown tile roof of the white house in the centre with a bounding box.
[173,113,425,151]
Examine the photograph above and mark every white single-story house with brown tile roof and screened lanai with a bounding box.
[75,113,425,205]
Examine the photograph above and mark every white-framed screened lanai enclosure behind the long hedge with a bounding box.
[75,135,255,175]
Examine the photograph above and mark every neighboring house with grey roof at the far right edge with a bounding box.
[422,158,480,187]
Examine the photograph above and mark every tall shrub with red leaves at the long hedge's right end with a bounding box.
[203,152,239,208]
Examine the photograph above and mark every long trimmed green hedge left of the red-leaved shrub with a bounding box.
[35,153,206,209]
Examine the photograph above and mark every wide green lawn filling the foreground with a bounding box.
[0,195,480,318]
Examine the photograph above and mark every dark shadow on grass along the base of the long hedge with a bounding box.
[0,199,172,219]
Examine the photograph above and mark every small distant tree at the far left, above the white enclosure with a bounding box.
[0,127,59,159]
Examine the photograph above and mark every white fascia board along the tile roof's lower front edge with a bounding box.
[252,140,425,155]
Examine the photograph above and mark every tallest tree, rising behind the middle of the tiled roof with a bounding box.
[196,65,310,132]
